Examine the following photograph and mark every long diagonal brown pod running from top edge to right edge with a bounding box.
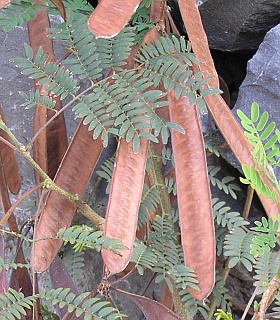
[178,0,280,219]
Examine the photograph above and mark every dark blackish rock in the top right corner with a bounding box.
[199,0,280,51]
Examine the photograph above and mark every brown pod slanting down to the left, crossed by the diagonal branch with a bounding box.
[30,121,103,272]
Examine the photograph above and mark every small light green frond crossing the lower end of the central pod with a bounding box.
[57,225,126,254]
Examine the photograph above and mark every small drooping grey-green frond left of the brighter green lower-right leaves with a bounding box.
[224,227,254,271]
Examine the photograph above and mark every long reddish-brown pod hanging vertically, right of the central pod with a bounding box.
[168,91,216,300]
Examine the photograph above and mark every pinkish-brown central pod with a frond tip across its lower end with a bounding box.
[102,138,149,276]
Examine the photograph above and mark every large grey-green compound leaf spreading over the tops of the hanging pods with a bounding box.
[14,17,205,152]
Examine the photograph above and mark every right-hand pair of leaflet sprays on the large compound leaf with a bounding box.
[136,35,209,105]
